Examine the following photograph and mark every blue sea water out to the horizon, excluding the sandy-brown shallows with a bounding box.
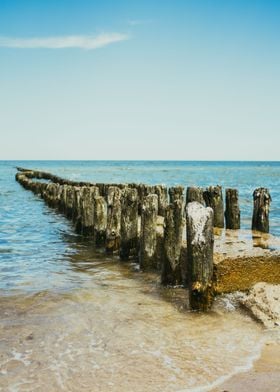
[0,161,280,293]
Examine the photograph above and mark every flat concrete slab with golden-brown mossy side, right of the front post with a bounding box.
[214,230,280,294]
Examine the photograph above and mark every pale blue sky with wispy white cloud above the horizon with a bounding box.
[0,0,280,160]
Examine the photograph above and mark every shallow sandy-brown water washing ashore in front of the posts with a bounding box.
[0,260,264,391]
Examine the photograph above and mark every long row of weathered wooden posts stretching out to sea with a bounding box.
[16,168,271,310]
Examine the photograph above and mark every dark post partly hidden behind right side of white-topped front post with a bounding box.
[203,185,225,229]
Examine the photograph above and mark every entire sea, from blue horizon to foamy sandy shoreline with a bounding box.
[0,161,280,392]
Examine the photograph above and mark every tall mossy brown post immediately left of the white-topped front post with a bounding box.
[161,199,183,286]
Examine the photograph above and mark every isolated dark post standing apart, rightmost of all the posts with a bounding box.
[252,188,271,233]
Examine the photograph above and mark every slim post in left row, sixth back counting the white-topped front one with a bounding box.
[93,196,107,247]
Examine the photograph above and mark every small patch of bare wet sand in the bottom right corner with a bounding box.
[211,342,280,392]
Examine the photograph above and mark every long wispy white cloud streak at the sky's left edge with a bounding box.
[0,33,129,50]
